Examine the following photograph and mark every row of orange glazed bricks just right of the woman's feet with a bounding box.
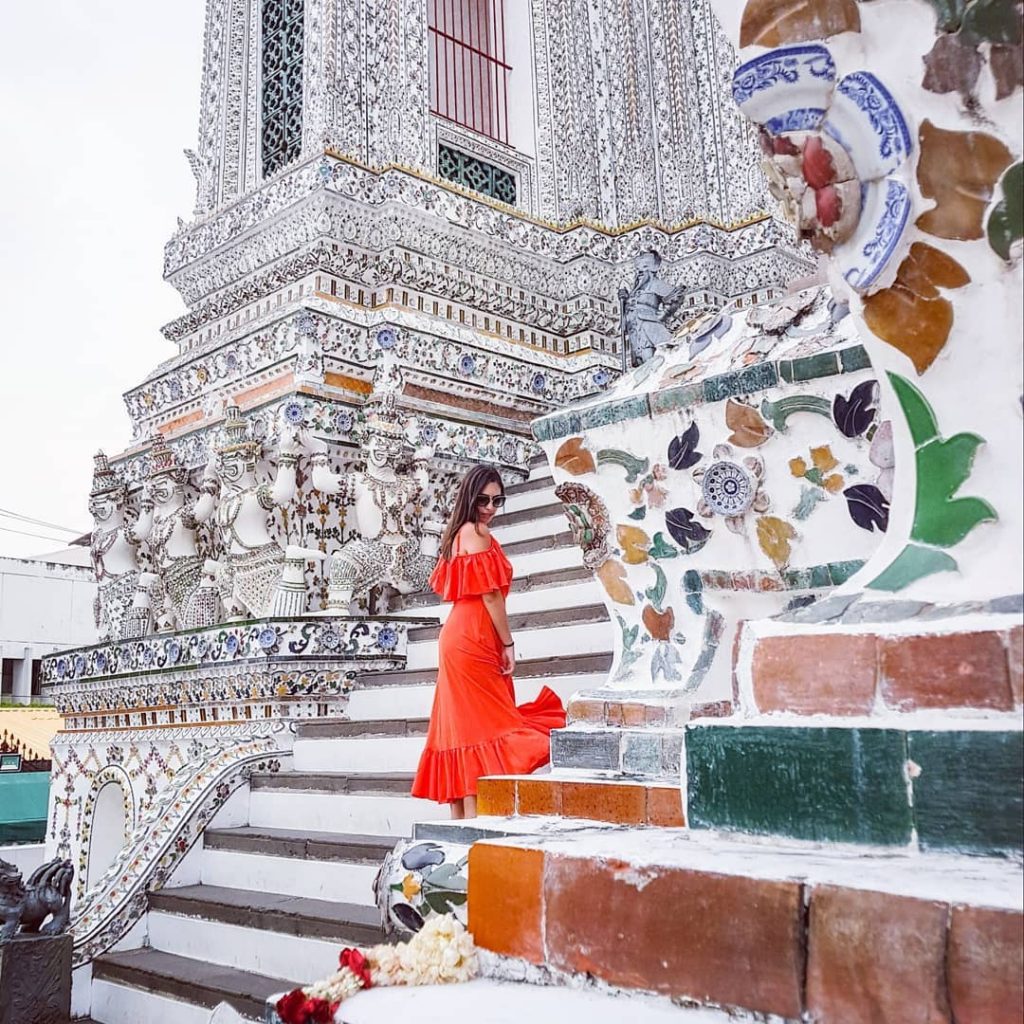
[477,774,684,827]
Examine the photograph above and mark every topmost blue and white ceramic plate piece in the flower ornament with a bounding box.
[732,44,836,134]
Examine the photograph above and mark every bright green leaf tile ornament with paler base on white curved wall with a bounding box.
[868,373,998,591]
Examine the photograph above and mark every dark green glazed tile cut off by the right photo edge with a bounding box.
[907,730,1024,854]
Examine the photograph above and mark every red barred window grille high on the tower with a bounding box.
[428,0,512,142]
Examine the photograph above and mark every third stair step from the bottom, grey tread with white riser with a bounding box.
[200,826,397,905]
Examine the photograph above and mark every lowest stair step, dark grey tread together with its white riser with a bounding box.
[91,949,290,1024]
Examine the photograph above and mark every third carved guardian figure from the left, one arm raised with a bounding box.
[201,406,325,618]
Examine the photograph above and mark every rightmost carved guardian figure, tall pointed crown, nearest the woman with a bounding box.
[313,355,441,612]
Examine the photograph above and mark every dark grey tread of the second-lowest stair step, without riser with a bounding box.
[150,885,384,939]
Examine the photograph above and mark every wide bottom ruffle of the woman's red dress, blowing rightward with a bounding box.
[412,686,565,804]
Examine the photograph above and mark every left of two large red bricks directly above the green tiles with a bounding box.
[751,633,878,715]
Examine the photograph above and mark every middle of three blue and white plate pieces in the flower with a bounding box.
[825,71,912,181]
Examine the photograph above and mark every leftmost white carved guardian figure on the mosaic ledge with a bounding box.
[89,452,144,640]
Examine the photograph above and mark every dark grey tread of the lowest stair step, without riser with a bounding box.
[92,949,292,1017]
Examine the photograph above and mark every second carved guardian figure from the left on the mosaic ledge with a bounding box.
[135,438,216,629]
